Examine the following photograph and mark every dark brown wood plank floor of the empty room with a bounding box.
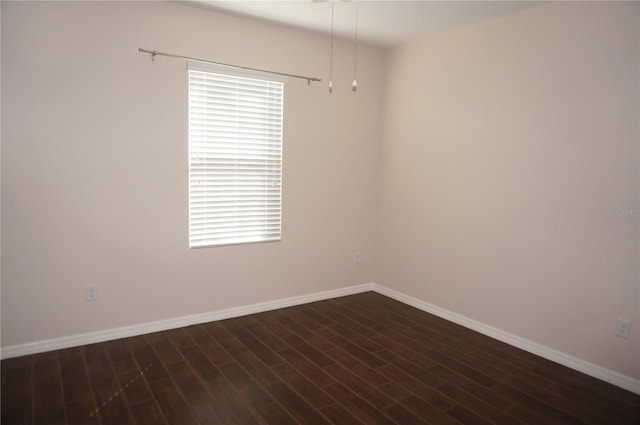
[2,292,640,425]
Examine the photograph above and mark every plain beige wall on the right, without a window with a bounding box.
[375,2,640,378]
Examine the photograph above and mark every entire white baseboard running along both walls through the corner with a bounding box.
[0,283,640,394]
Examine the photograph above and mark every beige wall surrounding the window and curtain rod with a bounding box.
[2,2,382,347]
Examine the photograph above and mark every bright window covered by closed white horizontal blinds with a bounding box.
[188,62,284,248]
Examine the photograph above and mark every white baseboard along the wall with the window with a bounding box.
[0,283,374,359]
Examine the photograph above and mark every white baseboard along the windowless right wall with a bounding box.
[373,284,640,394]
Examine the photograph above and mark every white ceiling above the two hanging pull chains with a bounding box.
[186,0,542,48]
